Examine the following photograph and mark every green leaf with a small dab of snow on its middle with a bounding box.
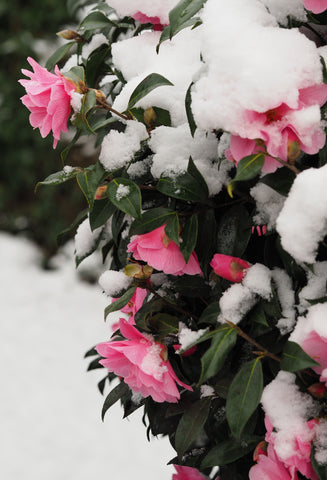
[107,177,142,218]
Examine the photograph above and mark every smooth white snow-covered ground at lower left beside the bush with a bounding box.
[0,233,174,480]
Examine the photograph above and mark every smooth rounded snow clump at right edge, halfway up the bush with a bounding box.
[277,165,327,263]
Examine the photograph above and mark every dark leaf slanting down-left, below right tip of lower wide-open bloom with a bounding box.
[175,397,210,460]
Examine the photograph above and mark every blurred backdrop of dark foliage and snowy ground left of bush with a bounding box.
[0,0,174,480]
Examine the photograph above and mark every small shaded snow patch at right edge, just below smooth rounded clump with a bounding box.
[299,262,327,313]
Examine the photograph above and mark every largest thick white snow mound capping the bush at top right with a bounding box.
[192,0,322,133]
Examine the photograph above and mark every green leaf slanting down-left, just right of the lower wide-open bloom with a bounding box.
[198,325,237,385]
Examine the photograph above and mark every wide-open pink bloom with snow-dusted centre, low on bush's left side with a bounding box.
[96,318,192,403]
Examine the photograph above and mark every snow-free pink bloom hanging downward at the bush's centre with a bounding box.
[127,225,202,275]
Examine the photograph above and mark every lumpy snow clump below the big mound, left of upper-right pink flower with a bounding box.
[149,123,233,199]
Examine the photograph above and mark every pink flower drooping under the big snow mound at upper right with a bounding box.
[225,84,327,172]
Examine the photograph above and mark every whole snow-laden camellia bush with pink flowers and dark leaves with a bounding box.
[20,0,327,480]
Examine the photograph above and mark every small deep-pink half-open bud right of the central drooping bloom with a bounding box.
[210,253,250,283]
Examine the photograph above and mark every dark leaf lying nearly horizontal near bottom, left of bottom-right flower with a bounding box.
[201,435,262,468]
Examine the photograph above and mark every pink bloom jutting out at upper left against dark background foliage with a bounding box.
[19,57,76,148]
